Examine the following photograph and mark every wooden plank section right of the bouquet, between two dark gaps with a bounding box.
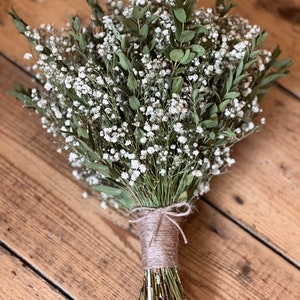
[207,88,300,267]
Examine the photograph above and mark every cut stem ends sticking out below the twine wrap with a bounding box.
[138,267,185,300]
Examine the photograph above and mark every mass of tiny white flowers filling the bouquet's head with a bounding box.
[21,0,278,209]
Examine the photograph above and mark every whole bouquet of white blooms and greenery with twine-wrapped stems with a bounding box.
[10,0,290,300]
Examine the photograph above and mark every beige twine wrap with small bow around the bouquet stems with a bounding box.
[129,203,193,270]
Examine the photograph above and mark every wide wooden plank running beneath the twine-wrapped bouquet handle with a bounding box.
[0,55,300,300]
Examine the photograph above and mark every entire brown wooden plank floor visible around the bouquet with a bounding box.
[0,0,300,300]
